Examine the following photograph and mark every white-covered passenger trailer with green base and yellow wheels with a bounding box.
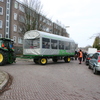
[23,30,75,65]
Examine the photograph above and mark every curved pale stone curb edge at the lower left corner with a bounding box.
[0,71,9,90]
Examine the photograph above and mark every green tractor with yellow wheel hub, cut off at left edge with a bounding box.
[0,38,16,66]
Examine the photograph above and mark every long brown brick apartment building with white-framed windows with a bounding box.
[0,0,69,53]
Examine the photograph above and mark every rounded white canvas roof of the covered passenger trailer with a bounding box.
[24,30,74,42]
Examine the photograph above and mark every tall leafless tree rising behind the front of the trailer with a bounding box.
[19,0,45,35]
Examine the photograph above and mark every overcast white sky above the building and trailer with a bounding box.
[19,0,100,47]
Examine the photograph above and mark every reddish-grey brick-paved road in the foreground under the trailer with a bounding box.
[0,59,100,100]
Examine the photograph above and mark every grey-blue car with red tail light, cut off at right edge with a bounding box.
[89,52,100,74]
